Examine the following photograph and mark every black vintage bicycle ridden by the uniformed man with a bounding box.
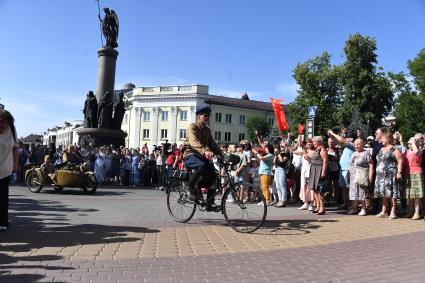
[166,155,267,233]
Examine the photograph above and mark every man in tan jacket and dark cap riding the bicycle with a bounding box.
[183,106,223,211]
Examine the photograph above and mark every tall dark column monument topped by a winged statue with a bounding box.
[78,8,127,146]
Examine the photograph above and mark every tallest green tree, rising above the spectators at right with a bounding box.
[339,33,394,132]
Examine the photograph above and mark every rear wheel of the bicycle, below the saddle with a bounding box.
[167,179,196,223]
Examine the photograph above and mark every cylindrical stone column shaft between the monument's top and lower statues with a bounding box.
[96,47,118,103]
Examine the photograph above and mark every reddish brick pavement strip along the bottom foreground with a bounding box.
[0,232,425,282]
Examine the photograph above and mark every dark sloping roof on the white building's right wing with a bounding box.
[205,94,273,111]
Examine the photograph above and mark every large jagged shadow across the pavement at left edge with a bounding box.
[0,195,159,282]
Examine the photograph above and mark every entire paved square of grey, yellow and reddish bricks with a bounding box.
[0,187,425,282]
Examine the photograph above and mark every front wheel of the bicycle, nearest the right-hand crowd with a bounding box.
[221,182,267,233]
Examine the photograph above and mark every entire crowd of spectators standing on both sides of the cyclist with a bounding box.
[8,125,425,219]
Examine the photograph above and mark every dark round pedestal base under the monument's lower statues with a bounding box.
[77,128,127,147]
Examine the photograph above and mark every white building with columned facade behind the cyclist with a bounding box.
[121,84,282,148]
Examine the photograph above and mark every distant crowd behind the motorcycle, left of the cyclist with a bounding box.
[12,142,182,190]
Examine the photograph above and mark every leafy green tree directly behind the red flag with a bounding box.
[288,52,342,138]
